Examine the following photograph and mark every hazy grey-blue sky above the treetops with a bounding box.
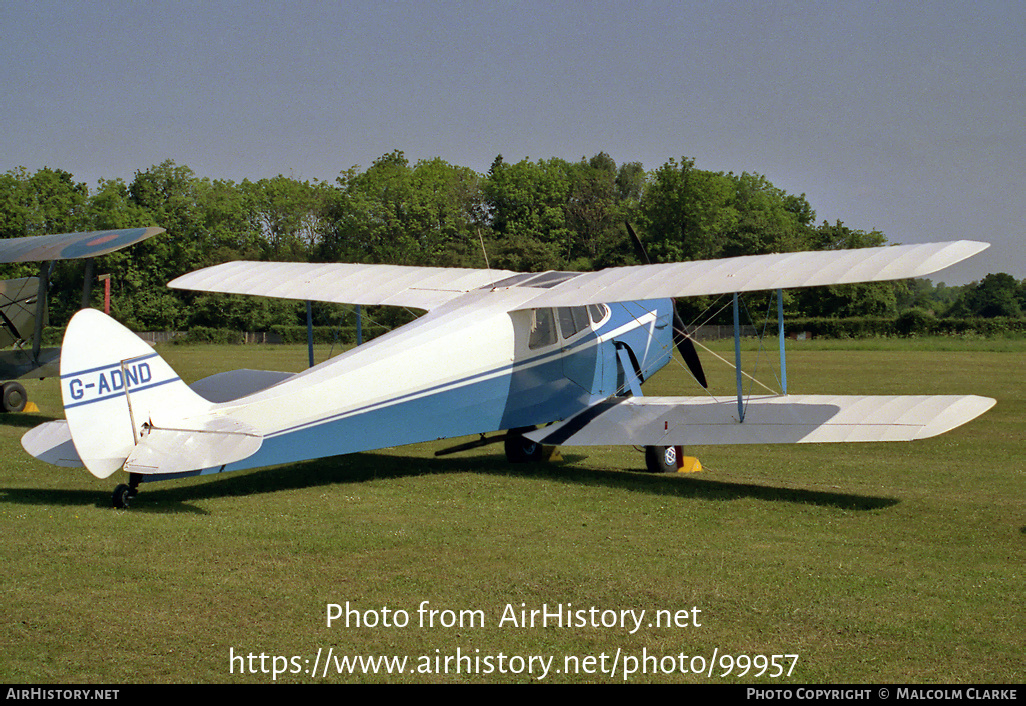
[0,0,1026,284]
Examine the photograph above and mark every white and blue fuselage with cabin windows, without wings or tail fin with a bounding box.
[190,292,672,479]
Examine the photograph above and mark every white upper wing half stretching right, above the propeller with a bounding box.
[508,240,990,309]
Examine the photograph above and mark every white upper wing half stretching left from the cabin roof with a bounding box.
[167,262,515,310]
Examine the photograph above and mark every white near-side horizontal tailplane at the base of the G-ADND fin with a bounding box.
[124,418,264,474]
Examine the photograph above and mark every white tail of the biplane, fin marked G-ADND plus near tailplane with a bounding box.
[61,309,263,478]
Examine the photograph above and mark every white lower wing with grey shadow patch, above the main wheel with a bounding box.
[525,395,995,446]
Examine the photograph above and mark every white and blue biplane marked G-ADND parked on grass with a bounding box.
[22,240,994,507]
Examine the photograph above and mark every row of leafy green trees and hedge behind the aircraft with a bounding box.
[0,151,1026,330]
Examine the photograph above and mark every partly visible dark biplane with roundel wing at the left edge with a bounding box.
[0,228,164,411]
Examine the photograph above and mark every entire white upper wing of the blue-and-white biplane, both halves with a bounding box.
[168,240,989,310]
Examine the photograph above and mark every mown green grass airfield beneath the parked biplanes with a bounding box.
[0,340,1026,683]
